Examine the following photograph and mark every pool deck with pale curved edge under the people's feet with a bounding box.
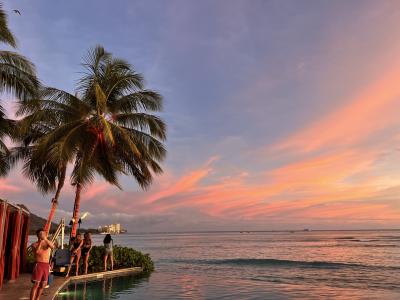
[0,267,143,300]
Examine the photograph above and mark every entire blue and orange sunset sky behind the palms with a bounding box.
[0,0,400,232]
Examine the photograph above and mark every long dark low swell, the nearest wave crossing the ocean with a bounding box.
[170,258,400,270]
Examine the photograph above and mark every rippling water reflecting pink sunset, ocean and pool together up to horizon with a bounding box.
[54,230,400,300]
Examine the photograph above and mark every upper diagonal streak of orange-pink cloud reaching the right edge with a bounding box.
[273,65,400,152]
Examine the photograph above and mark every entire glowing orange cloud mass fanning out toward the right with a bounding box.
[75,62,400,227]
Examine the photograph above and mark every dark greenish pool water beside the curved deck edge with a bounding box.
[56,274,148,300]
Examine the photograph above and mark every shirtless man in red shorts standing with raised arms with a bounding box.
[30,229,54,300]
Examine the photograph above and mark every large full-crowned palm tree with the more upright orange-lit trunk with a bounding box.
[19,46,166,236]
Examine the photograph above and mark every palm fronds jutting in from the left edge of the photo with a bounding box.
[0,4,39,176]
